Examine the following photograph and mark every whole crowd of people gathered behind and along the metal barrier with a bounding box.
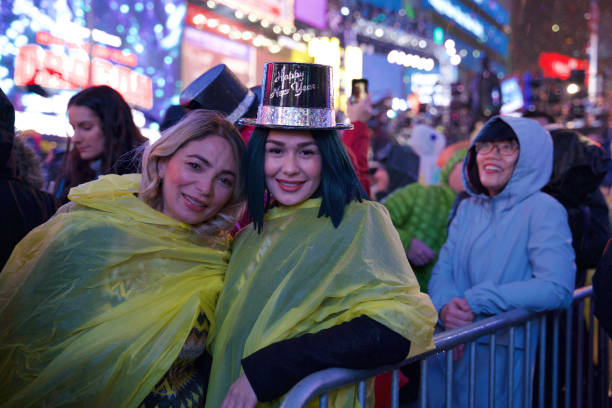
[0,63,612,408]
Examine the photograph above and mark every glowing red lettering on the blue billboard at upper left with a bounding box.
[14,32,153,109]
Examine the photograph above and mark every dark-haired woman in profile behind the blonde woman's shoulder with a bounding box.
[53,85,147,203]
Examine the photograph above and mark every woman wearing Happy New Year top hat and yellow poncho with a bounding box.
[207,63,437,408]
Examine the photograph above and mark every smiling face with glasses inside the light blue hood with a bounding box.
[476,141,520,196]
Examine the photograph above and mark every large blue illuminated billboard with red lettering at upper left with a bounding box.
[0,0,186,121]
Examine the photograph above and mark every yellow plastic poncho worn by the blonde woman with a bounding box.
[0,174,229,408]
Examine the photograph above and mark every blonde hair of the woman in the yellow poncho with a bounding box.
[140,109,245,238]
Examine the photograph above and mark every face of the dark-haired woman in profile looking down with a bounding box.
[68,105,104,160]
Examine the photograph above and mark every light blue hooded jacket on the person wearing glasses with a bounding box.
[429,117,576,315]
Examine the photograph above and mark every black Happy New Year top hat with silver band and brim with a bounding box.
[238,62,353,130]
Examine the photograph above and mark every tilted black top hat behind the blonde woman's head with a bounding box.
[180,64,257,123]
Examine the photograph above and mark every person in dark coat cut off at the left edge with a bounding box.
[0,90,57,270]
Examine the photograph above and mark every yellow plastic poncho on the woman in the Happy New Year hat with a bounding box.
[206,199,437,407]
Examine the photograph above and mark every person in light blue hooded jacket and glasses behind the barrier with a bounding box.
[427,116,576,407]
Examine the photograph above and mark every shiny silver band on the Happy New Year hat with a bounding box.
[257,105,336,129]
